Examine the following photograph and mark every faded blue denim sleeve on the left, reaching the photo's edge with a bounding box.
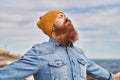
[0,44,39,80]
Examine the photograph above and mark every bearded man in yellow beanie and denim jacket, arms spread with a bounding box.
[0,10,120,80]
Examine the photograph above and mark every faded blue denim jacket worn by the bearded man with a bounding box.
[0,38,112,80]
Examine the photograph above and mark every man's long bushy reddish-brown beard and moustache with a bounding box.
[54,19,78,46]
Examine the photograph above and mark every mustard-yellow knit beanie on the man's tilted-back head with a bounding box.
[37,10,61,37]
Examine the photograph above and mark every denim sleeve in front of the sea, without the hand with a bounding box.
[87,59,112,80]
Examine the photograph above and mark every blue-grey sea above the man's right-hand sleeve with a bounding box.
[92,59,120,73]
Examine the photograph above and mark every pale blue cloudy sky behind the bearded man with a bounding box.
[0,0,120,59]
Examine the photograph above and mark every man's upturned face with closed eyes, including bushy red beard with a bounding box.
[53,12,77,46]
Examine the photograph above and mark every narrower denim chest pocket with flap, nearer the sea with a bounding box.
[77,59,87,78]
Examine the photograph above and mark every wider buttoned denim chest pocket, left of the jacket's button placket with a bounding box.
[49,59,67,80]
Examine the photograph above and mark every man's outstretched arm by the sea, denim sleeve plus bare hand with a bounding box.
[87,60,120,80]
